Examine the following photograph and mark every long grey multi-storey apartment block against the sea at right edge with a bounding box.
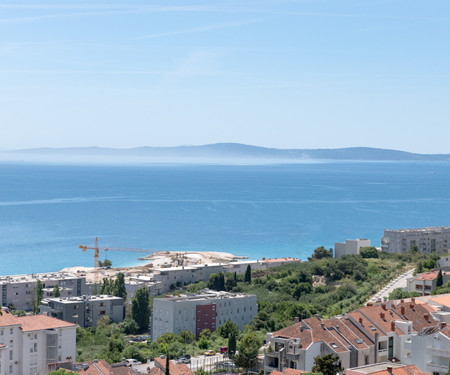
[381,227,450,253]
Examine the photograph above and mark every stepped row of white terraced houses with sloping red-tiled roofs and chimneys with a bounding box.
[264,301,439,374]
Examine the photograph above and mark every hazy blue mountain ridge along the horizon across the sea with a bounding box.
[4,143,450,162]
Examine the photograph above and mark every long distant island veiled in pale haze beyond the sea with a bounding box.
[0,143,450,163]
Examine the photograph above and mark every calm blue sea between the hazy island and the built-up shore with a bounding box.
[0,162,450,275]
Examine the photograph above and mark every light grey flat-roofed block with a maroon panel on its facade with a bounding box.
[151,289,258,341]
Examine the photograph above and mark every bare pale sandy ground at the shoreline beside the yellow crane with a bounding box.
[61,251,244,282]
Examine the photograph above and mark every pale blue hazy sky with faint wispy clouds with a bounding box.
[0,0,450,153]
